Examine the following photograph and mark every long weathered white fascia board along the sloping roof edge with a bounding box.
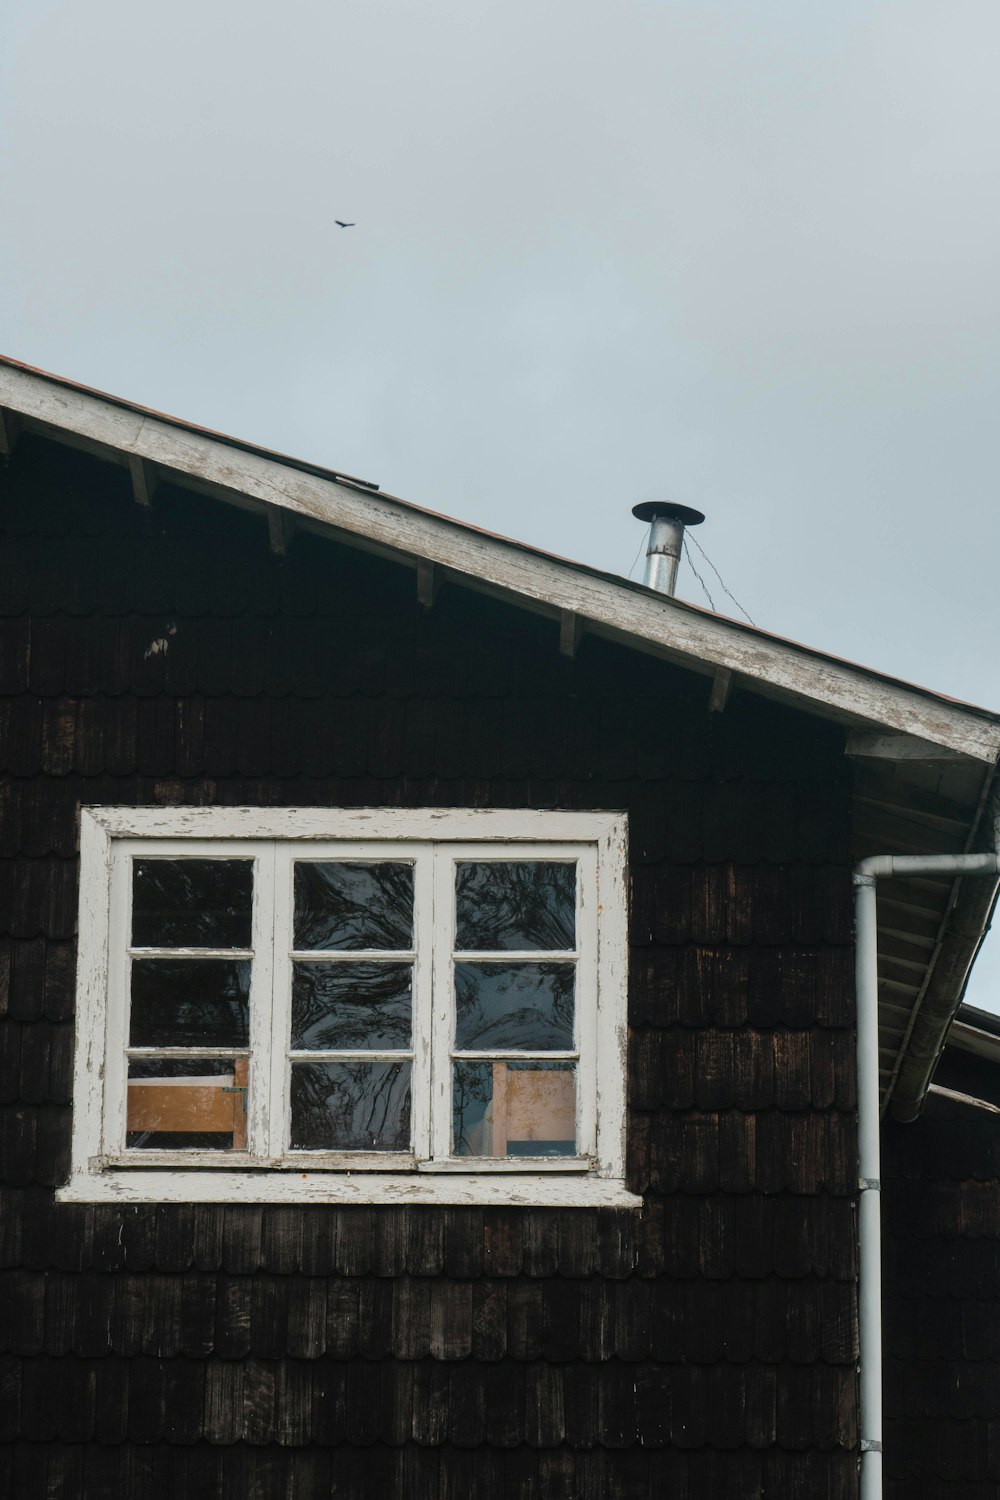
[0,365,1000,764]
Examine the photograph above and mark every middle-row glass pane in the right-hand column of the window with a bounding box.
[454,963,576,1052]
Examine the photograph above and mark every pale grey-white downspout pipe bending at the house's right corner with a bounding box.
[853,854,1000,1500]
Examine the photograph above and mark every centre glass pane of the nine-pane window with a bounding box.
[292,963,414,1052]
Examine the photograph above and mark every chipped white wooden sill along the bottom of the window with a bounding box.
[55,1169,642,1209]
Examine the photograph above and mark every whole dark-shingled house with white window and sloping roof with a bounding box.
[0,360,1000,1500]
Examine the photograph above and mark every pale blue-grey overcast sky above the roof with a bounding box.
[0,0,1000,1010]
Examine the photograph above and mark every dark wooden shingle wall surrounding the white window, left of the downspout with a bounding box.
[0,438,856,1500]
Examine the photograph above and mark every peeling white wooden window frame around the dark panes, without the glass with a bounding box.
[57,807,642,1208]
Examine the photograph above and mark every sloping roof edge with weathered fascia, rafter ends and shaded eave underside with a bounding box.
[0,343,1000,1113]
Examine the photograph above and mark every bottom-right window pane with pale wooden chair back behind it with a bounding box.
[451,1062,577,1157]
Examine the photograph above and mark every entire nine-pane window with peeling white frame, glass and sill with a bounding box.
[60,809,639,1205]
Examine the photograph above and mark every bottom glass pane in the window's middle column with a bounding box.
[291,1062,411,1151]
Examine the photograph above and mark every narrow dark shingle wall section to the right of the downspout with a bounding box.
[883,1086,1000,1500]
